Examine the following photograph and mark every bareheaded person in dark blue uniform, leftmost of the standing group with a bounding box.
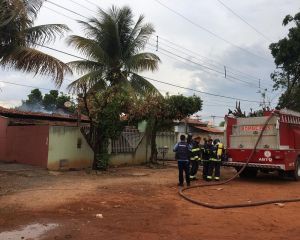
[173,135,190,187]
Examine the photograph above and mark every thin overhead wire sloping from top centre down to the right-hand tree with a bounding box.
[154,0,271,62]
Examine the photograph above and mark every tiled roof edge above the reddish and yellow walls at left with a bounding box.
[0,106,89,122]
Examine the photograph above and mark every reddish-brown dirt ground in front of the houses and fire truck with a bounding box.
[0,161,300,240]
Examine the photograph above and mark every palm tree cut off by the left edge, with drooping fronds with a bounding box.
[0,0,72,86]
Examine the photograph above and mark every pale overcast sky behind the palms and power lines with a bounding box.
[0,0,300,124]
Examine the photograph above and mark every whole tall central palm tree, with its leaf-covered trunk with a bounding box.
[68,6,160,171]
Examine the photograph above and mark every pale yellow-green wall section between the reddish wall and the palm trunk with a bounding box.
[47,126,94,170]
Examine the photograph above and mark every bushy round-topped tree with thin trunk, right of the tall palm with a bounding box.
[131,94,202,163]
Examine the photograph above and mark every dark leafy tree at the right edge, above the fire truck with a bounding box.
[270,12,300,111]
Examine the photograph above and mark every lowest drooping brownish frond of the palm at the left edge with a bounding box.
[0,46,72,87]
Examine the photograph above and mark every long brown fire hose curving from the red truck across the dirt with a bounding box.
[178,112,300,209]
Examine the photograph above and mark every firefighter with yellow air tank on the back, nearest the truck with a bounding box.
[207,139,224,181]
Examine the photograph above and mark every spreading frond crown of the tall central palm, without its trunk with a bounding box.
[68,6,160,94]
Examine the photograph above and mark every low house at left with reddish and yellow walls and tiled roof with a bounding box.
[0,107,94,170]
